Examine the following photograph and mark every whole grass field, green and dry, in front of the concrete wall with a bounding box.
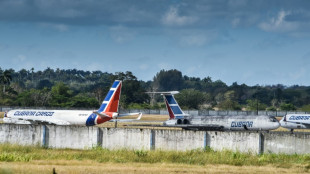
[0,144,310,173]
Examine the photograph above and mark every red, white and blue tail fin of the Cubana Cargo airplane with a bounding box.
[97,80,122,113]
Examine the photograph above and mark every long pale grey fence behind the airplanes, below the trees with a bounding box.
[0,106,310,117]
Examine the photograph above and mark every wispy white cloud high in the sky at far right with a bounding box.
[259,10,298,32]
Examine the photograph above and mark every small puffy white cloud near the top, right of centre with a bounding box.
[162,7,197,26]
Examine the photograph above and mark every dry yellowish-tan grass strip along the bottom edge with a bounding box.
[0,160,307,174]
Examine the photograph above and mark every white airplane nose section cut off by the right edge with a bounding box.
[280,114,310,132]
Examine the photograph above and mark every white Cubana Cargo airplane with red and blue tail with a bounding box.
[3,80,142,126]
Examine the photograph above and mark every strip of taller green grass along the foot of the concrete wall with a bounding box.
[0,144,310,170]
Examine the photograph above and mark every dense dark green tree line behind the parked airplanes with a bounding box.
[0,68,310,111]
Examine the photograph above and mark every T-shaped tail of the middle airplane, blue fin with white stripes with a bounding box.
[148,91,188,120]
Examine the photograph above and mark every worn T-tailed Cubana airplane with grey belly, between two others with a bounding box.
[148,91,280,131]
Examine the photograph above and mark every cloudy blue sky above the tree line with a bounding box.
[0,0,310,86]
